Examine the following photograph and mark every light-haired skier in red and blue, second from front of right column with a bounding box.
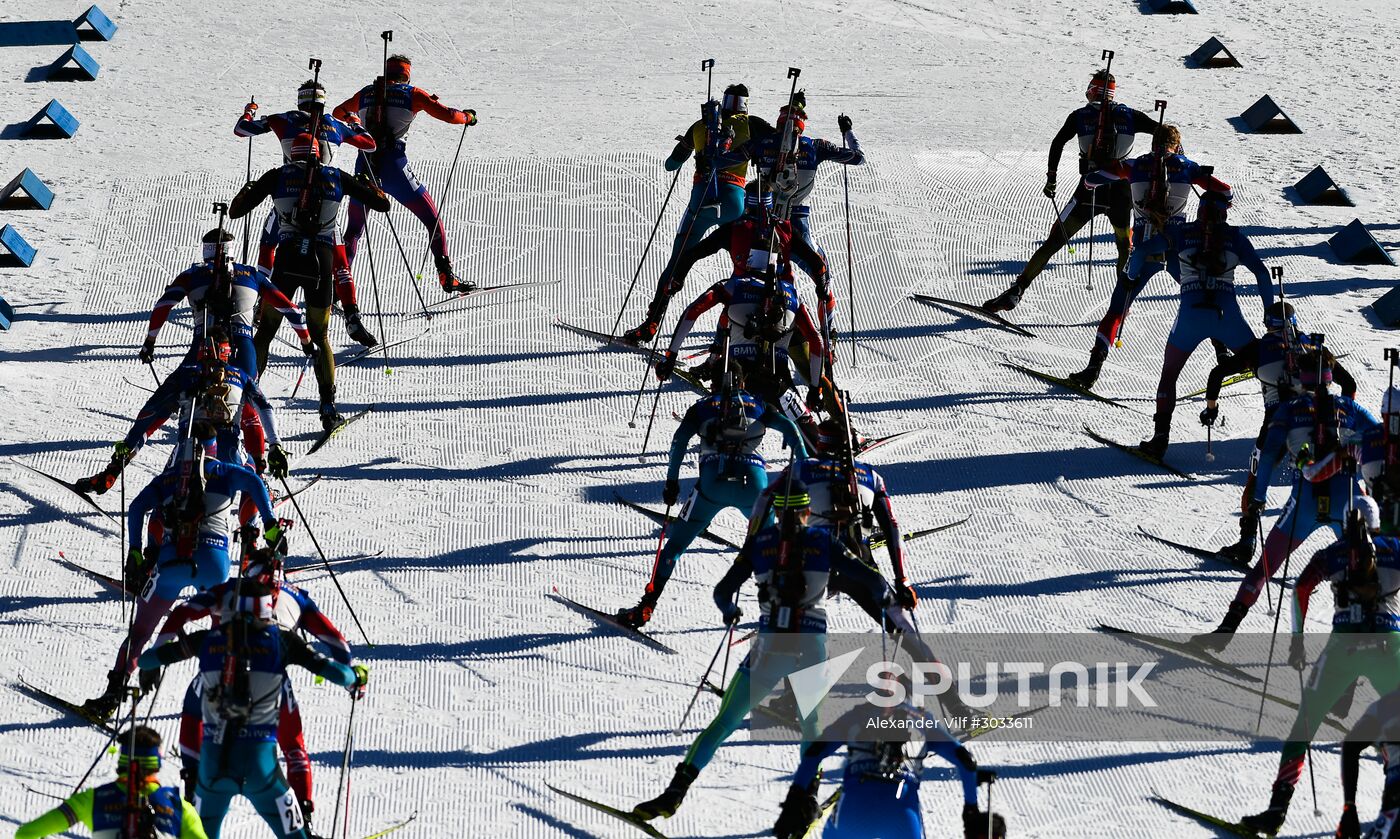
[1068,125,1235,389]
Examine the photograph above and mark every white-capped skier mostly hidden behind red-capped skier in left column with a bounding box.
[234,78,375,324]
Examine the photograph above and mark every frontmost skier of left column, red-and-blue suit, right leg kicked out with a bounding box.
[332,55,476,291]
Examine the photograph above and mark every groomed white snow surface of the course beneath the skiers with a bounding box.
[0,0,1400,838]
